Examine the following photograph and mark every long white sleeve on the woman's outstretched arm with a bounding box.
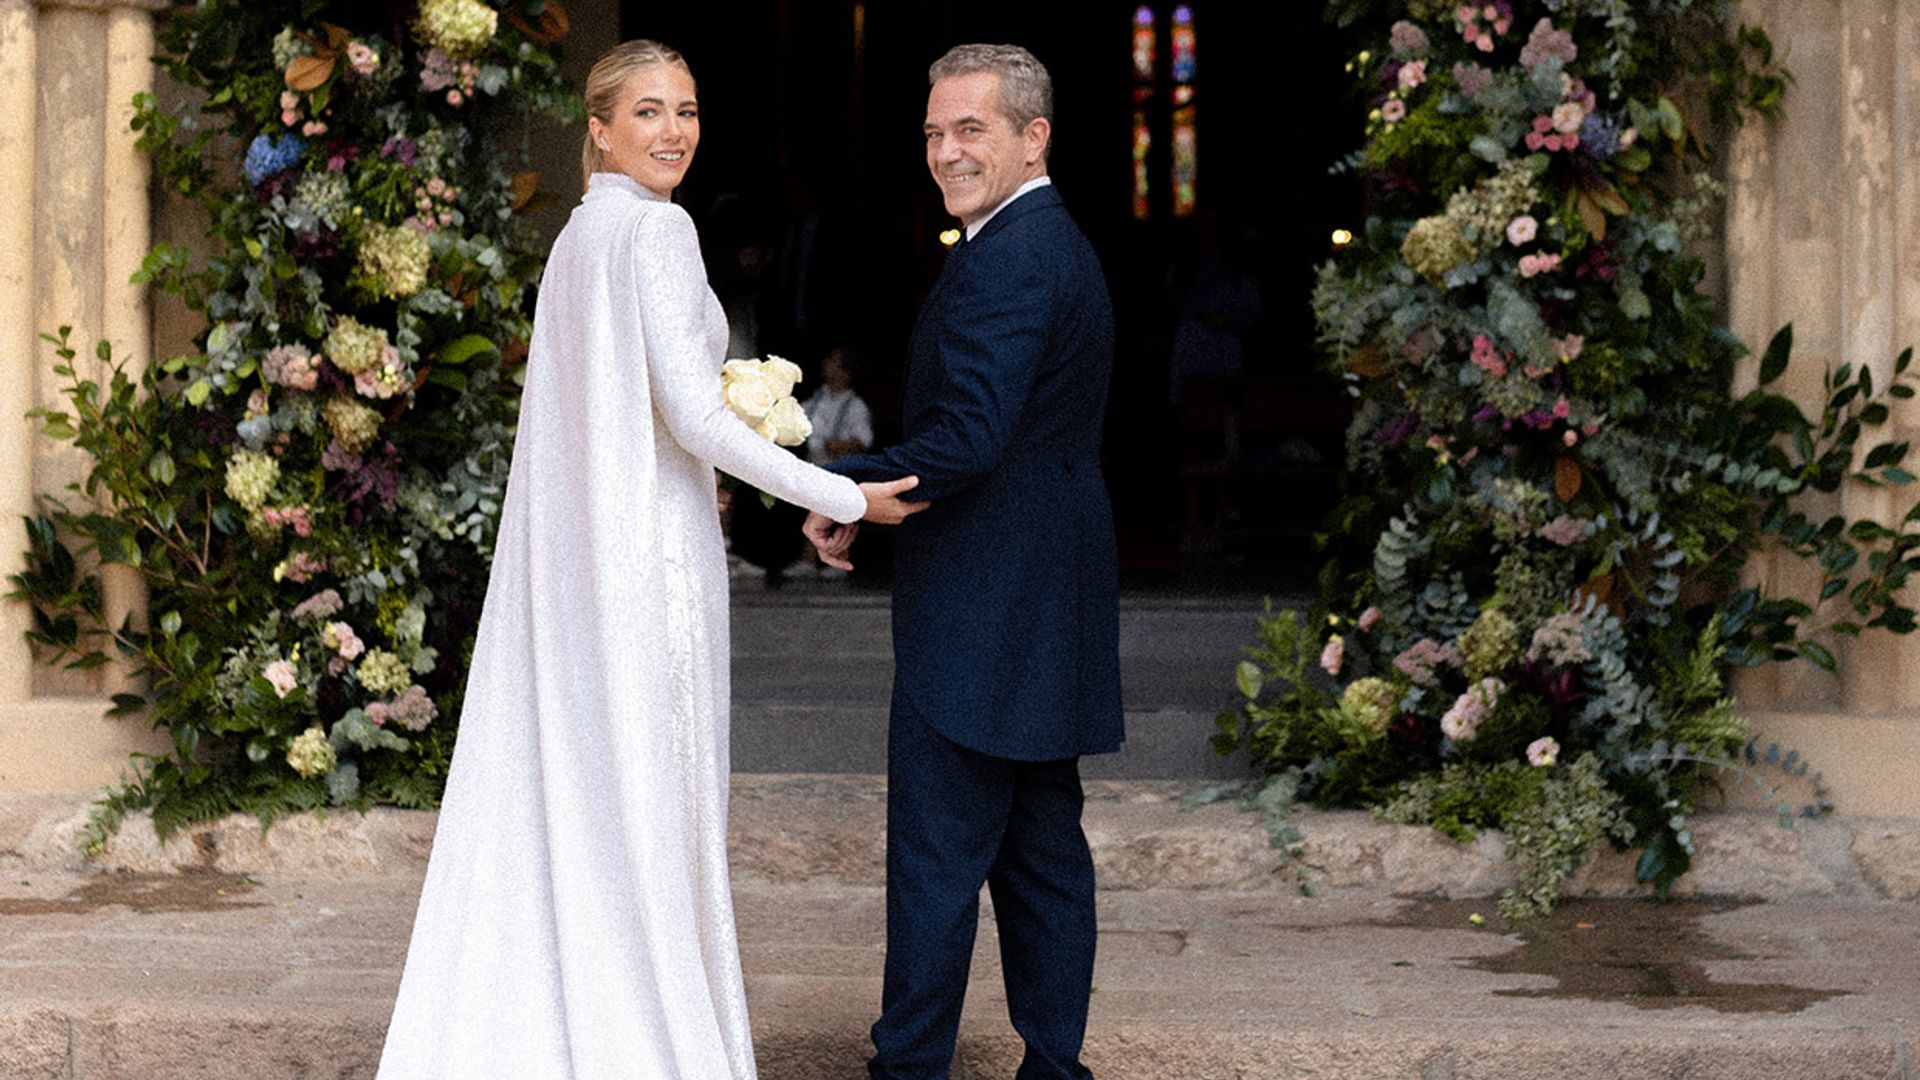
[634,204,866,523]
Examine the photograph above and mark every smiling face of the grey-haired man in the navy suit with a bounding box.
[925,71,1048,225]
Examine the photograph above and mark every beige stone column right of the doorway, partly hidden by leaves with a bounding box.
[1726,0,1920,817]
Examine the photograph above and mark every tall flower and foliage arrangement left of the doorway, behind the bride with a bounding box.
[15,0,582,844]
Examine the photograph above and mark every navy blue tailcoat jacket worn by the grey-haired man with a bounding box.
[831,184,1125,761]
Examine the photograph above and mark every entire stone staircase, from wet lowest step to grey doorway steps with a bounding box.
[0,588,1920,1080]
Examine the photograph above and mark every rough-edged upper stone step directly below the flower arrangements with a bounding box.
[0,774,1920,899]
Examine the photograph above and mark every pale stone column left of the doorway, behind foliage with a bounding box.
[0,0,161,788]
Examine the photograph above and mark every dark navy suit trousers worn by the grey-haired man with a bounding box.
[868,701,1096,1080]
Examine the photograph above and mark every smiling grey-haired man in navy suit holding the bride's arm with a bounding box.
[806,44,1123,1080]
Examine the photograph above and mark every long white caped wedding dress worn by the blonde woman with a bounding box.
[378,173,866,1080]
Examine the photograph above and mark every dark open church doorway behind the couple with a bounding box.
[620,0,1363,588]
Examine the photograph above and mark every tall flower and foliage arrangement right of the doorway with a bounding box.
[1215,0,1920,915]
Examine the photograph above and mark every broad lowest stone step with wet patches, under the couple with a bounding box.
[0,874,1920,1080]
